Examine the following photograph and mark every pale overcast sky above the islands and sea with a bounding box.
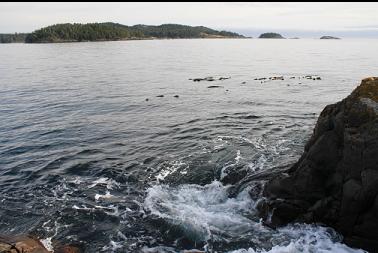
[0,2,378,37]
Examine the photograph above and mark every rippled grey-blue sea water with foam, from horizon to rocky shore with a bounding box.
[0,39,378,253]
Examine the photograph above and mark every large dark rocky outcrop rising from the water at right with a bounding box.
[258,77,378,252]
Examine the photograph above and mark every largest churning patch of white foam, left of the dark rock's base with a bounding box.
[144,181,254,241]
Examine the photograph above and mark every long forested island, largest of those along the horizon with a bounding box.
[0,22,245,43]
